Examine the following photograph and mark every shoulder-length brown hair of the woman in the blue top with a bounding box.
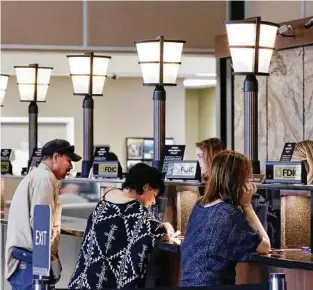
[198,151,252,206]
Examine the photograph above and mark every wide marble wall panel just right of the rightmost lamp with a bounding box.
[267,48,303,160]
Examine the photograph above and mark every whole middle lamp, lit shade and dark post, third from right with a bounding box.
[67,52,111,177]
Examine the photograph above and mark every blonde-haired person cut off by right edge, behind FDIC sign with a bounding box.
[293,140,313,184]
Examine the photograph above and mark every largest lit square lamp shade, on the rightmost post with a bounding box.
[225,17,279,75]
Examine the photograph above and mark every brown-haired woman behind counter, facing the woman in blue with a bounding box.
[196,138,225,180]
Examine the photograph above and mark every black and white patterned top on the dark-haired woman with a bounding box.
[69,200,166,289]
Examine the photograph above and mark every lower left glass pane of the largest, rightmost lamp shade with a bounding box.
[230,48,254,72]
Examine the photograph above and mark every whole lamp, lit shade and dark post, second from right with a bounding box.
[135,36,185,170]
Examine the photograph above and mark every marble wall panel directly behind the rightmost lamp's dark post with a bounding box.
[234,76,267,172]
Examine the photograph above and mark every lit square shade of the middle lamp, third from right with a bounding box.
[67,52,111,96]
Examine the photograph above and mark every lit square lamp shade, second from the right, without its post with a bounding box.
[135,36,186,86]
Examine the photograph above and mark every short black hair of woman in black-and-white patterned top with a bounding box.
[122,163,164,195]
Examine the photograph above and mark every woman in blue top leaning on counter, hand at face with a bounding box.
[181,151,271,287]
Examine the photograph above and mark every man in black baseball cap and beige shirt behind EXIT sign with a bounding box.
[5,139,81,290]
